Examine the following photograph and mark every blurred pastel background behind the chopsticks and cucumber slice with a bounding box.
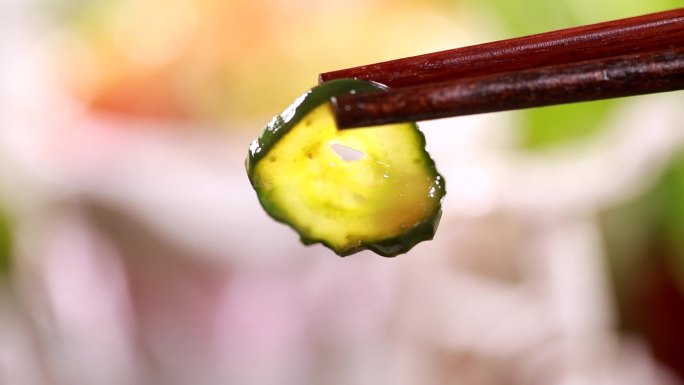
[0,0,684,385]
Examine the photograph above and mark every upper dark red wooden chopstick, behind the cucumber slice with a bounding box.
[319,8,684,88]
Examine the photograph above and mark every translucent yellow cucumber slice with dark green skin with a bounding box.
[246,79,446,257]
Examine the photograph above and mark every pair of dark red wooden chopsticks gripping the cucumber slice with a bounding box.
[319,8,684,129]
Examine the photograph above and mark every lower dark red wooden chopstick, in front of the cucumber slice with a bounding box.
[332,48,684,128]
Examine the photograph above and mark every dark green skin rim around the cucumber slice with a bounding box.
[245,79,446,257]
